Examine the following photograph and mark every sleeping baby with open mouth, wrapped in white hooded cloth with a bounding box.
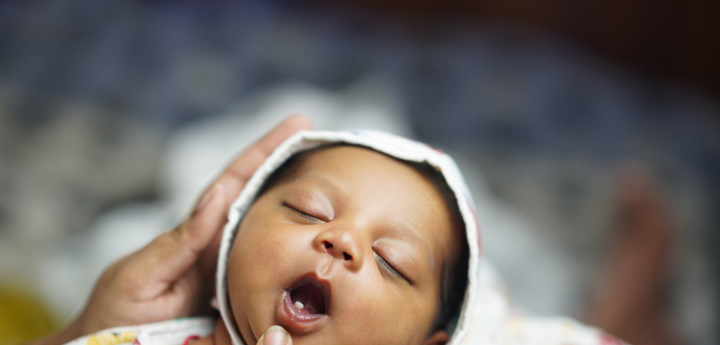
[57,126,621,345]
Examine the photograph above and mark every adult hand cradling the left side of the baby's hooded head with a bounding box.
[29,116,311,344]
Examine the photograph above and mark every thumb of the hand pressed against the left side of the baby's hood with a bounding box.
[132,183,227,293]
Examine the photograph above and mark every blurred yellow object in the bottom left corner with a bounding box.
[0,285,57,345]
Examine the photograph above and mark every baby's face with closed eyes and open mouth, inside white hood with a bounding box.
[228,146,455,345]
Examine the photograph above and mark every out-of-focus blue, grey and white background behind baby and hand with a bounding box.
[0,0,720,345]
